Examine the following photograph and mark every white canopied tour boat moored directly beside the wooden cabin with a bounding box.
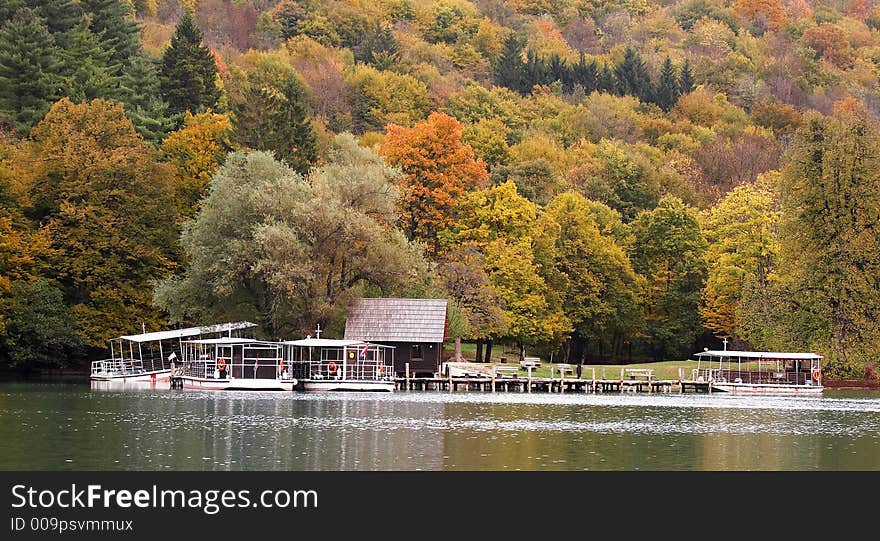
[282,328,394,392]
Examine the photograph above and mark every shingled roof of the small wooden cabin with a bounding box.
[345,298,446,343]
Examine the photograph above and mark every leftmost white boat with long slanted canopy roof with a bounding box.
[89,321,256,383]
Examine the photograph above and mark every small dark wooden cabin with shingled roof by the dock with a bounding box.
[345,298,448,376]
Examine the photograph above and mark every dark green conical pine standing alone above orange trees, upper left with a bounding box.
[160,11,220,113]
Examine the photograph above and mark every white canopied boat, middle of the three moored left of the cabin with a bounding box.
[171,337,296,391]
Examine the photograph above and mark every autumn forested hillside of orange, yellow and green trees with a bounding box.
[0,0,880,377]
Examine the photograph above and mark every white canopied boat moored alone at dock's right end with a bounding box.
[692,350,822,395]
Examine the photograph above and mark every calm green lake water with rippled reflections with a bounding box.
[0,383,880,470]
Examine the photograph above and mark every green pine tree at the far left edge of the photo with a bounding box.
[0,8,64,134]
